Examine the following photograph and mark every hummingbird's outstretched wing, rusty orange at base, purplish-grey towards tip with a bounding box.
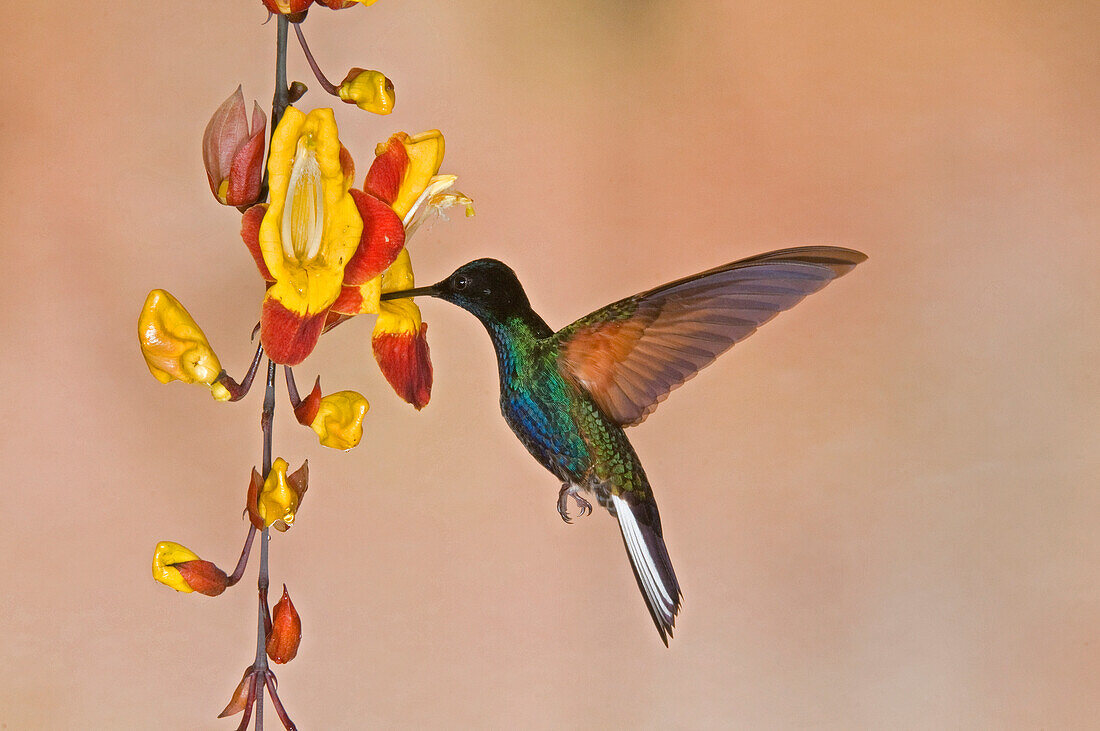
[553,246,867,427]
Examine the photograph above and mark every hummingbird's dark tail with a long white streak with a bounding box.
[612,492,682,647]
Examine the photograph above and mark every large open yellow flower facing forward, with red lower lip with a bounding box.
[259,107,363,365]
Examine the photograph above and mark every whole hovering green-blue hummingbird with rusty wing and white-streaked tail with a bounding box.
[382,246,867,646]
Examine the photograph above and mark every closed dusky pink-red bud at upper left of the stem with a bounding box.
[202,87,267,206]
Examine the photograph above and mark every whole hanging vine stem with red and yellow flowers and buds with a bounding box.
[138,0,473,729]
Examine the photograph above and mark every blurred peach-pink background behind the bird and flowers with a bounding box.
[0,0,1100,729]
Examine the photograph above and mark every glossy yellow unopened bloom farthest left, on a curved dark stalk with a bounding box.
[138,289,230,401]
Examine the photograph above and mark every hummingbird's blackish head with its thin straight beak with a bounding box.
[382,259,531,320]
